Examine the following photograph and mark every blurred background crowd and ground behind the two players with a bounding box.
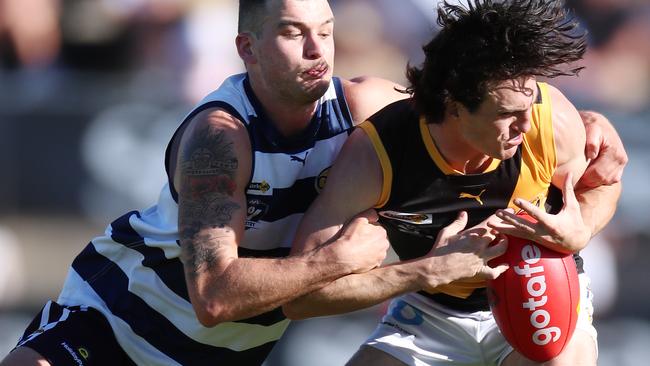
[0,0,650,366]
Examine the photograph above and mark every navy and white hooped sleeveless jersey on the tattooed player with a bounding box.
[58,74,353,366]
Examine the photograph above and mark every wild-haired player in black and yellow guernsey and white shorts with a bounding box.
[284,0,620,366]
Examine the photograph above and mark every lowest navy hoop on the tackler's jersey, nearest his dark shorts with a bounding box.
[72,244,275,365]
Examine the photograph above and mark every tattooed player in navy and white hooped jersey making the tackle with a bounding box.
[3,0,624,366]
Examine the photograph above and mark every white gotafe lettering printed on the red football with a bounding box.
[514,244,562,346]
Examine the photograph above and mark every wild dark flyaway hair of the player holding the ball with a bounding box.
[406,0,586,123]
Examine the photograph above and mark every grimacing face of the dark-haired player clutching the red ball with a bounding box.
[459,77,537,160]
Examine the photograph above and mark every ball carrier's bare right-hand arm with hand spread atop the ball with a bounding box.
[492,87,621,253]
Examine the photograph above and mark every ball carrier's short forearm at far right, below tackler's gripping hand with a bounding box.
[576,183,622,237]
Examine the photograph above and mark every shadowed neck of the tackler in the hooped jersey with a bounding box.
[249,74,318,137]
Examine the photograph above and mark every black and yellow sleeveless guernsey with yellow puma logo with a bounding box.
[360,83,576,311]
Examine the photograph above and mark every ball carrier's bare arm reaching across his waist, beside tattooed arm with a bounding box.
[283,129,505,319]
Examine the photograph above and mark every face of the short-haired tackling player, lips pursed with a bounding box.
[254,0,334,103]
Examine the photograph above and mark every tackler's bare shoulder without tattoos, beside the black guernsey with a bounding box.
[341,76,409,123]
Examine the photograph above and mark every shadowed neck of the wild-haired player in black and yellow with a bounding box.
[427,119,492,174]
